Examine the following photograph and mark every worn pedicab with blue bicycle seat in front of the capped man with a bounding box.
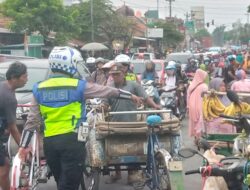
[84,110,184,190]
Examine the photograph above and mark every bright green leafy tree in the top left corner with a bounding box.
[1,0,75,43]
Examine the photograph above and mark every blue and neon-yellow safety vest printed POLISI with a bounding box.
[33,78,86,137]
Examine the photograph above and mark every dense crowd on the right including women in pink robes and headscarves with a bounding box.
[186,51,250,143]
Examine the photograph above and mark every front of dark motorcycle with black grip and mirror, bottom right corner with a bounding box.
[178,148,250,190]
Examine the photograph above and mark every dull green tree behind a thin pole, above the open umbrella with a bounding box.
[72,0,137,47]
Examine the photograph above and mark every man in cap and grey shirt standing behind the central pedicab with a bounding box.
[103,63,160,184]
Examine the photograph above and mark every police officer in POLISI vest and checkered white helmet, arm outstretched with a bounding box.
[19,47,141,190]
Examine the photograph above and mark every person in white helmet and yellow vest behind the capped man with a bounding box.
[115,54,139,82]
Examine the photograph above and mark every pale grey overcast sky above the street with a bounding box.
[110,0,250,31]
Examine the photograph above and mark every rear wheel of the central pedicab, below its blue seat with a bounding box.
[155,152,171,190]
